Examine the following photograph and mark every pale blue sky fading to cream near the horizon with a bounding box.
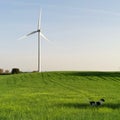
[0,0,120,71]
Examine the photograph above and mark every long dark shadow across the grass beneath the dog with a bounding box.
[55,103,120,109]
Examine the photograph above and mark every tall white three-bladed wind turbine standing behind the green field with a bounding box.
[19,10,49,72]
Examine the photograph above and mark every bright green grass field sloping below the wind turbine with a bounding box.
[0,72,120,120]
